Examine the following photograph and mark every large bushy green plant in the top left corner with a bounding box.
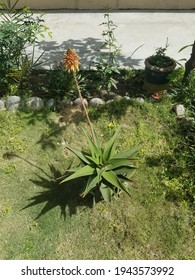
[0,0,51,91]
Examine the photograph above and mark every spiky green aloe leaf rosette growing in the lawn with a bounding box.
[61,130,139,202]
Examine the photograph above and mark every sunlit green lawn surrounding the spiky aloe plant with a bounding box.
[0,99,195,259]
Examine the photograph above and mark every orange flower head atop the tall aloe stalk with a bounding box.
[64,48,80,72]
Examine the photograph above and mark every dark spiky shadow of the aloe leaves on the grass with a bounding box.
[21,165,93,220]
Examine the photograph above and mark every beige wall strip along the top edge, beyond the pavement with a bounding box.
[4,0,195,9]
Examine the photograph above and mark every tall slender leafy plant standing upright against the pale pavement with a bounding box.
[96,13,121,92]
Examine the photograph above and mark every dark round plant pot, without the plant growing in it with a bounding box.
[145,56,176,91]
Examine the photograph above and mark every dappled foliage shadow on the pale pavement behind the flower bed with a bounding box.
[37,37,141,69]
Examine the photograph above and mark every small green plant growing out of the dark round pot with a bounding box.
[149,38,173,68]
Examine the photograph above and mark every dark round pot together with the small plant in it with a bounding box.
[144,40,176,92]
